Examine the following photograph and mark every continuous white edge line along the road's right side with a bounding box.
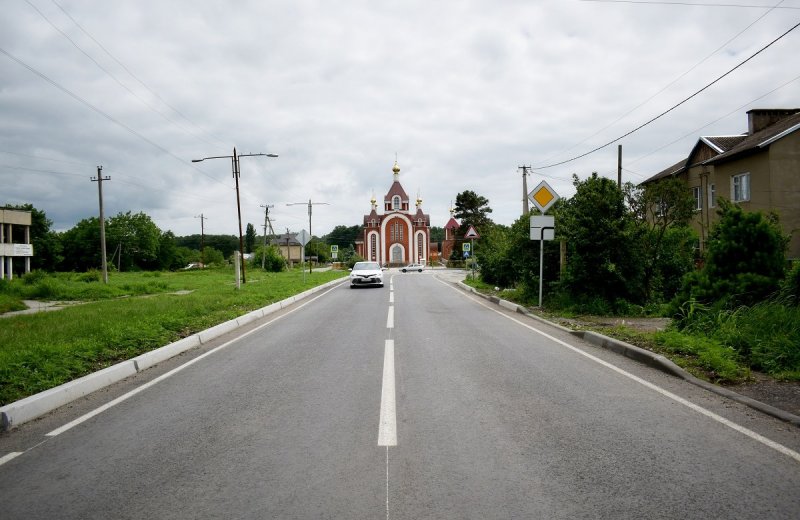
[437,279,800,462]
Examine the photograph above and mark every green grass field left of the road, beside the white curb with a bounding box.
[0,270,346,405]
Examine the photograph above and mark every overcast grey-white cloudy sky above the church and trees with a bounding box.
[0,0,800,236]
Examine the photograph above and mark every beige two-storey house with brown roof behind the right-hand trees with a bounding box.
[642,108,800,258]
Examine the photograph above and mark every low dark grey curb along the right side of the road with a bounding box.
[457,282,800,426]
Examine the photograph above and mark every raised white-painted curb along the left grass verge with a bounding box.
[0,278,347,431]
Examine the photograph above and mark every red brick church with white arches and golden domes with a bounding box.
[356,161,431,266]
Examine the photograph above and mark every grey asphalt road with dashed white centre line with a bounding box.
[0,271,800,520]
